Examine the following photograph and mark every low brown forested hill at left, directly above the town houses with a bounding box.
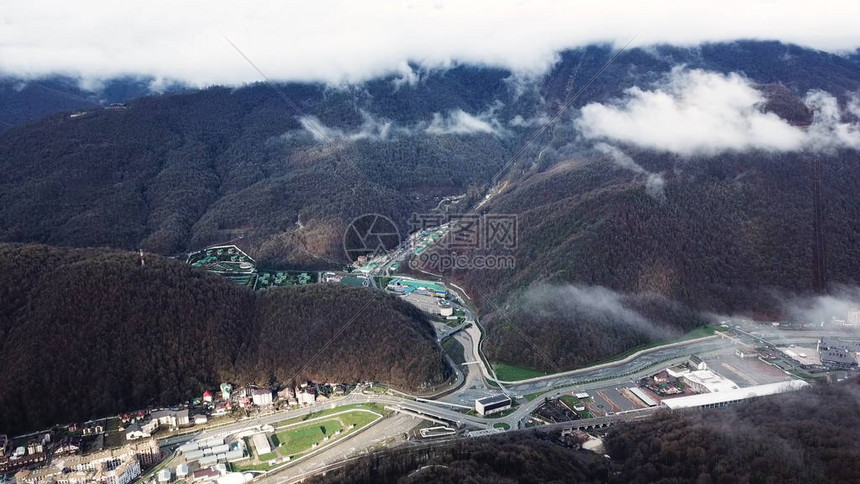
[0,244,451,433]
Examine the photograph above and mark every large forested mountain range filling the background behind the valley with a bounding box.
[0,41,860,369]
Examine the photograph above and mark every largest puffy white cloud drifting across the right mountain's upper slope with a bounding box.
[575,68,860,156]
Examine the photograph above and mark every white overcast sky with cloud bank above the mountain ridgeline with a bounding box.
[0,0,860,85]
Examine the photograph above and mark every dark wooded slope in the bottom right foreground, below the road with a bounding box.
[315,380,860,484]
